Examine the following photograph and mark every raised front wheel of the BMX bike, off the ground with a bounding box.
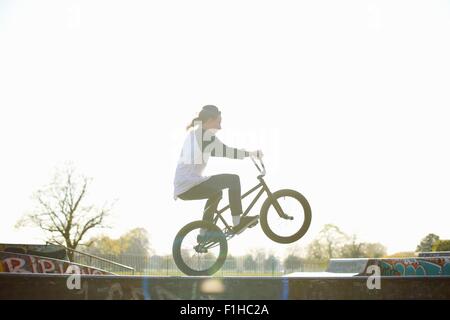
[260,189,312,243]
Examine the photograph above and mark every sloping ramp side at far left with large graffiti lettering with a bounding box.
[0,251,111,275]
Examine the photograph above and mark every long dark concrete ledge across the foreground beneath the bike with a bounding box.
[0,273,450,300]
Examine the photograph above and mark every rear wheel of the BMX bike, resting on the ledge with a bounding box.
[172,221,228,276]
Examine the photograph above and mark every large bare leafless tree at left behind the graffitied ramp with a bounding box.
[17,166,111,260]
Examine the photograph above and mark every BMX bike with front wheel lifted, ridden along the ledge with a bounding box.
[172,157,311,276]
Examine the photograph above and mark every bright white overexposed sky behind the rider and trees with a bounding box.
[0,0,450,254]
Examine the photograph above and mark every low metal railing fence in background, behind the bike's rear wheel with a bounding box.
[74,254,327,276]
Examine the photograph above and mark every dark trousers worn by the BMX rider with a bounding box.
[178,173,242,220]
